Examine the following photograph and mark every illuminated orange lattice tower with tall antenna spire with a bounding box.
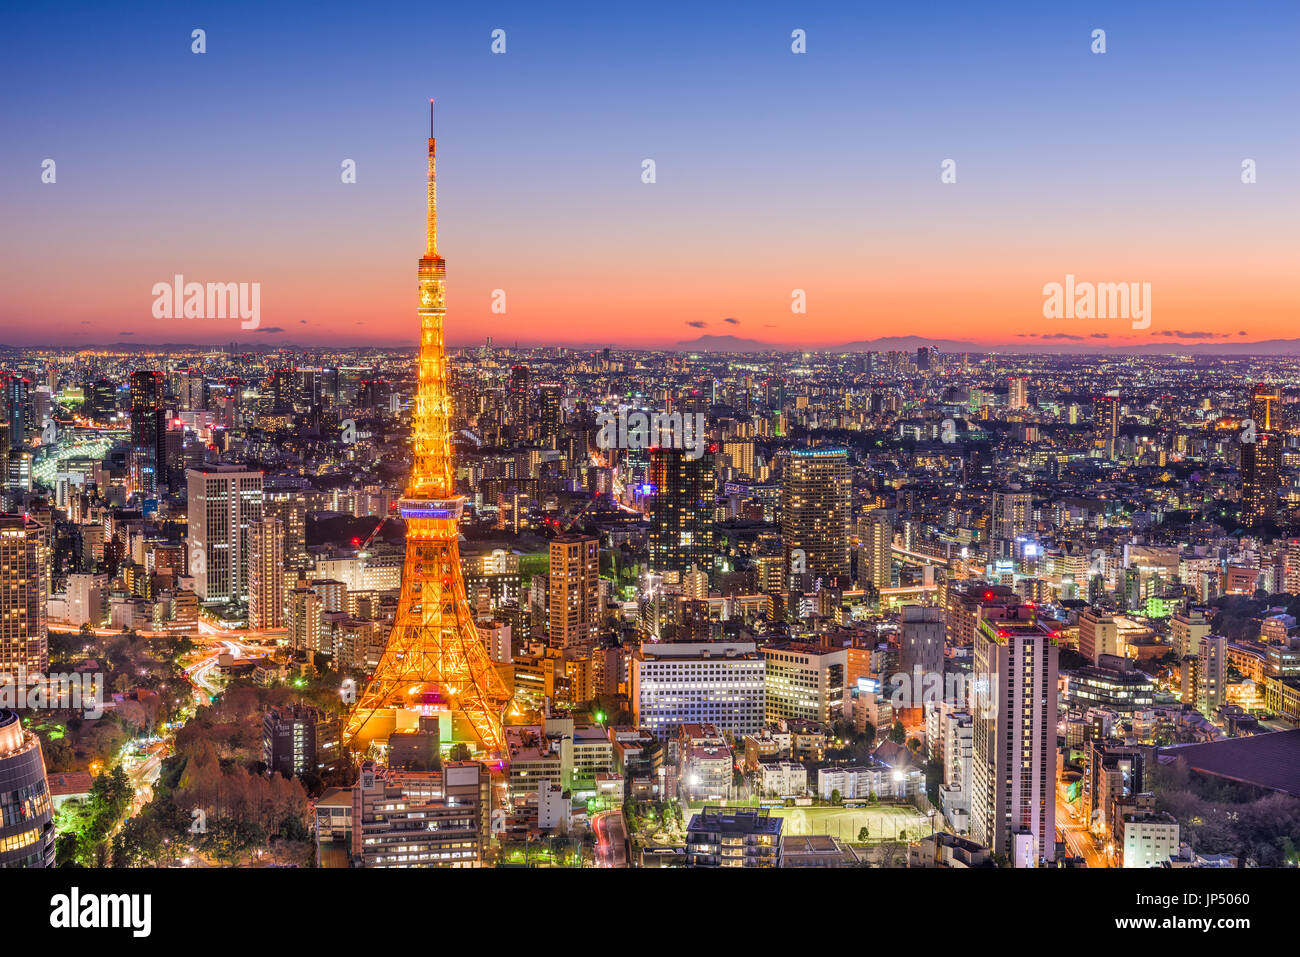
[343,100,511,753]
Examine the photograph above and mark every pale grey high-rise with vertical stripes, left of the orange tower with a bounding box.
[186,465,263,603]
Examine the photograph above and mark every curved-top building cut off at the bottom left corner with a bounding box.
[0,709,55,870]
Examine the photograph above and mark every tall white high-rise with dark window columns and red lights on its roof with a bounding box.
[971,610,1060,866]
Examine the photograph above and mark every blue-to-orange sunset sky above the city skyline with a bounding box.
[0,0,1300,348]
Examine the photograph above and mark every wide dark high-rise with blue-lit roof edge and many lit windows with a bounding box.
[781,449,853,588]
